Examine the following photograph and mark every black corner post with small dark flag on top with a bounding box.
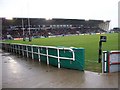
[98,36,107,63]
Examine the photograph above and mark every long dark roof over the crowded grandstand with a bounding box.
[3,18,104,25]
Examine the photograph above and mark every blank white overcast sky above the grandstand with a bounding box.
[0,0,119,28]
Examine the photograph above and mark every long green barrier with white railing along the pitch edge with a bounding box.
[2,43,85,70]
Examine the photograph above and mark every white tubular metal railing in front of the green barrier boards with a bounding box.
[2,43,75,68]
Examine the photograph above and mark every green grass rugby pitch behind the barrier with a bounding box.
[5,33,118,72]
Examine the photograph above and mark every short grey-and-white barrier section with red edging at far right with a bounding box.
[102,51,120,73]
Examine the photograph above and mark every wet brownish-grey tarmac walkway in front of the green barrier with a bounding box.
[0,52,118,88]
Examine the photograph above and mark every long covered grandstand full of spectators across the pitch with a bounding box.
[2,18,110,39]
